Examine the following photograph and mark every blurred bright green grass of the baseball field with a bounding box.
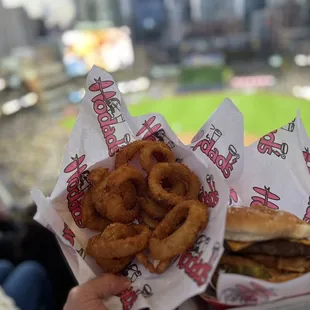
[129,92,310,136]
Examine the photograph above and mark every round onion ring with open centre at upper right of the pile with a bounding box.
[148,163,200,206]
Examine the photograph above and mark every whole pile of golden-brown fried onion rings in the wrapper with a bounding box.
[82,140,208,274]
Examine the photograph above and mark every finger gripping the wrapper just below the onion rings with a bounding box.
[84,274,131,298]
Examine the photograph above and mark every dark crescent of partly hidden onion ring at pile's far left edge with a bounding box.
[81,189,111,232]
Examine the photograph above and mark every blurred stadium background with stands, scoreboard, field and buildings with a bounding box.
[0,0,310,209]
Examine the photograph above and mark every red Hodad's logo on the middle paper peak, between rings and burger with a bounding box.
[192,124,240,179]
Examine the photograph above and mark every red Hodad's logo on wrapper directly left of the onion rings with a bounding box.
[64,155,90,228]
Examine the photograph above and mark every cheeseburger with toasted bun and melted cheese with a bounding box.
[218,206,310,282]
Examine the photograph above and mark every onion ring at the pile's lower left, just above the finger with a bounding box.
[87,223,151,259]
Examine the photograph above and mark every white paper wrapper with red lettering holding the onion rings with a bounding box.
[32,67,231,309]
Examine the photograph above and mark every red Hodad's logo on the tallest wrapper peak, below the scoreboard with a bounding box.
[89,77,130,157]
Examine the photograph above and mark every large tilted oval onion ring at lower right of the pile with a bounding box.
[149,200,208,261]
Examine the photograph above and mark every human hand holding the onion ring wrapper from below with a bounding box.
[64,274,131,310]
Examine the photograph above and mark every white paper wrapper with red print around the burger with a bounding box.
[204,113,310,309]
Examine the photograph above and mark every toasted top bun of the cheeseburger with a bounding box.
[225,206,310,242]
